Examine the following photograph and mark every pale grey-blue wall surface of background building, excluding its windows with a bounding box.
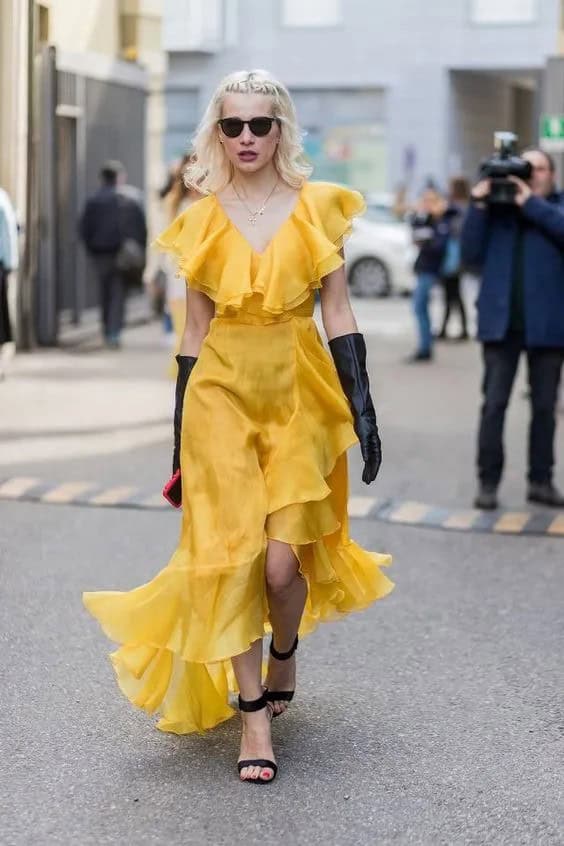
[161,0,560,190]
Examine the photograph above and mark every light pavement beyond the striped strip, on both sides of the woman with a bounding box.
[0,300,564,511]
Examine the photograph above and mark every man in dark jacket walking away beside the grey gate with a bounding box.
[80,162,147,349]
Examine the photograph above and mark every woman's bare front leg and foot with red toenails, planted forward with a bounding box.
[231,640,274,781]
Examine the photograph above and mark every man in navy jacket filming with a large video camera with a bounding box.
[461,150,564,509]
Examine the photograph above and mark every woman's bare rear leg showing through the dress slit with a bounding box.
[266,540,307,714]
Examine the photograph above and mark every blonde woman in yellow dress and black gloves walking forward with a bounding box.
[84,71,392,784]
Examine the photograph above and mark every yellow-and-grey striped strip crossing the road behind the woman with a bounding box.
[0,476,564,537]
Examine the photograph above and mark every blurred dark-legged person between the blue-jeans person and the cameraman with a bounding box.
[436,176,470,341]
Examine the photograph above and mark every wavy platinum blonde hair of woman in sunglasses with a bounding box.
[184,70,313,194]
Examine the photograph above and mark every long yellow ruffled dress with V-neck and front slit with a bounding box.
[84,183,393,734]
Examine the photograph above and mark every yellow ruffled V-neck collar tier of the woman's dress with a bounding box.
[156,182,365,315]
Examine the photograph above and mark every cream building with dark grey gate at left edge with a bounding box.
[0,0,166,346]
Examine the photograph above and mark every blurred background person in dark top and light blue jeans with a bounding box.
[408,188,449,363]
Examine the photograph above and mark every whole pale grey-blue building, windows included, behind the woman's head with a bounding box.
[163,0,562,192]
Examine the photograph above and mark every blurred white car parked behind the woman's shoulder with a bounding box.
[345,195,416,297]
